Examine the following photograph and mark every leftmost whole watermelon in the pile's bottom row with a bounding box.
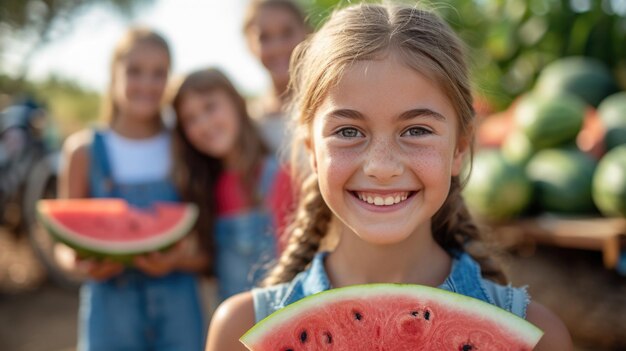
[463,150,532,221]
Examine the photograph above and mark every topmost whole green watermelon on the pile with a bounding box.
[536,56,617,106]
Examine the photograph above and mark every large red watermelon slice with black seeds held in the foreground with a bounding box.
[240,284,543,351]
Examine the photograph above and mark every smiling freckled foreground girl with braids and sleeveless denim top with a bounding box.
[207,5,571,351]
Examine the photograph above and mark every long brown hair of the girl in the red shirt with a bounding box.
[172,69,269,274]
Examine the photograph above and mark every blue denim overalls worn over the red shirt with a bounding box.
[215,157,279,301]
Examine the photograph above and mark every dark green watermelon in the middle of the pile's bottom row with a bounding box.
[526,147,596,213]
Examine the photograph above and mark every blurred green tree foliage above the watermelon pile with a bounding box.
[301,0,626,109]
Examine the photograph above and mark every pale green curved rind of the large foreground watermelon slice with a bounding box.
[239,283,543,349]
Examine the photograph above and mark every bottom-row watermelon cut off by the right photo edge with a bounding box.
[593,145,626,217]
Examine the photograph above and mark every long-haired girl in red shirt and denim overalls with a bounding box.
[168,69,292,300]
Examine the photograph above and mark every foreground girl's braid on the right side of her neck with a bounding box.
[432,176,507,283]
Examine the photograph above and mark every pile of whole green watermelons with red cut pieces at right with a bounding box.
[465,57,626,222]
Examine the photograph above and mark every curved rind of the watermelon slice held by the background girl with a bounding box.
[37,202,198,262]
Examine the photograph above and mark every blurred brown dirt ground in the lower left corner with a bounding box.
[0,229,78,351]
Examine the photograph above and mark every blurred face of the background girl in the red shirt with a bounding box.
[178,89,240,159]
